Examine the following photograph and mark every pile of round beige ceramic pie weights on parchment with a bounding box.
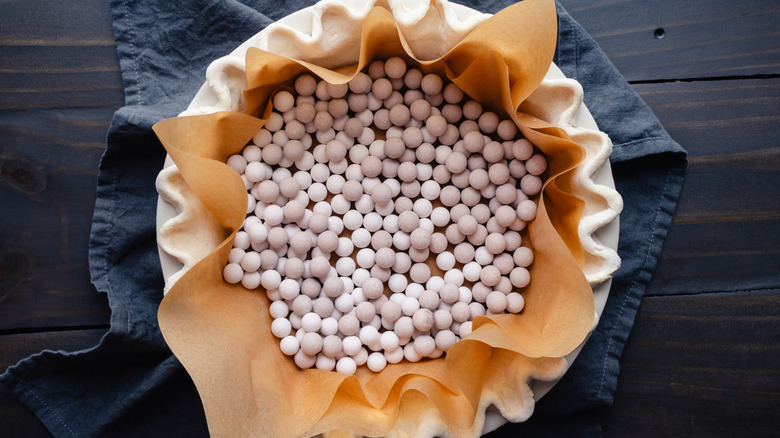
[223,57,547,374]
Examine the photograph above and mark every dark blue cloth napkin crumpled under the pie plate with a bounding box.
[0,0,686,437]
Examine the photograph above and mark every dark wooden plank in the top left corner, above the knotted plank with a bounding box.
[0,0,124,111]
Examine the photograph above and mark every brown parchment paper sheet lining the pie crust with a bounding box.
[155,0,608,437]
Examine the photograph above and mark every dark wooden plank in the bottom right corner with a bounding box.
[602,289,780,437]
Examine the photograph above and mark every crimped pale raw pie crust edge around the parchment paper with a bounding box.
[158,1,622,431]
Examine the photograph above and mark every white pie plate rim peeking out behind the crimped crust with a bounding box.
[156,0,620,434]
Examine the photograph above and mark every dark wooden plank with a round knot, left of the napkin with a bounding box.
[0,109,113,330]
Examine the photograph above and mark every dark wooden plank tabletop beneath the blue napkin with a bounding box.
[0,0,780,437]
